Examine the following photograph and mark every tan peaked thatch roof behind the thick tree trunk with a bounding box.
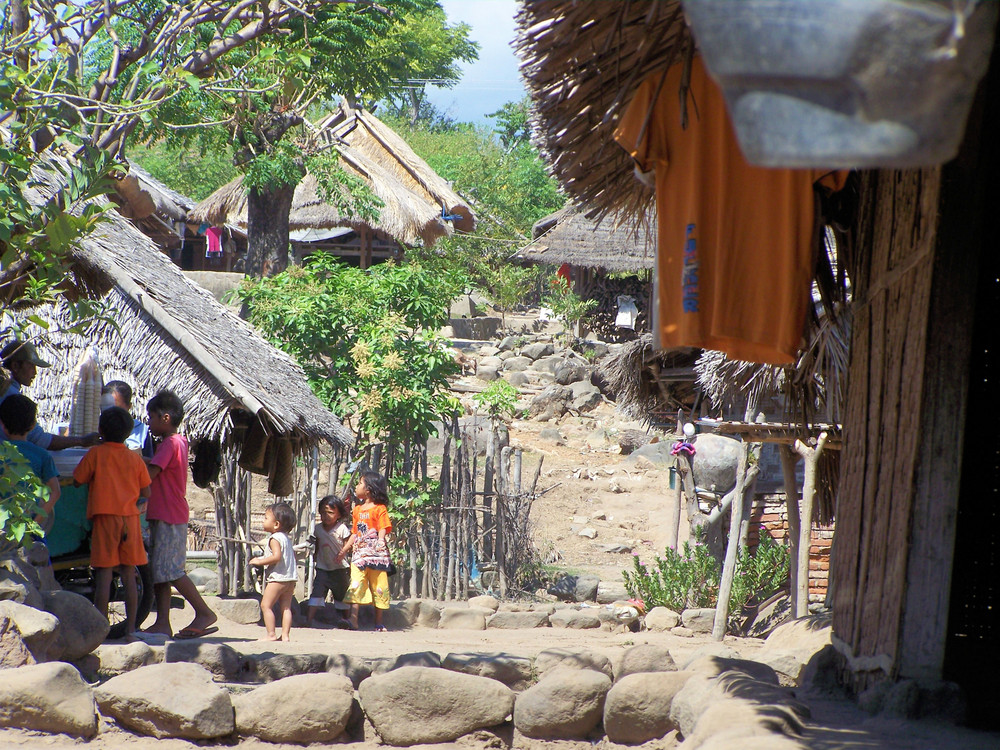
[189,103,476,246]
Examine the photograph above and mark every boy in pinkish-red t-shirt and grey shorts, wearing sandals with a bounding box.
[145,390,218,639]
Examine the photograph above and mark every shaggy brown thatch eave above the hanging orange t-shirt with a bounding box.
[516,0,690,216]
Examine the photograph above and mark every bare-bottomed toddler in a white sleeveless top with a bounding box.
[250,503,298,641]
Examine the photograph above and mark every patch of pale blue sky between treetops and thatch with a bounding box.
[427,0,525,125]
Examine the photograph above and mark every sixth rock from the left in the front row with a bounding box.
[604,672,691,745]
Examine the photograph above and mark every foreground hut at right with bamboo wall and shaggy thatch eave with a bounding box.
[518,0,1000,725]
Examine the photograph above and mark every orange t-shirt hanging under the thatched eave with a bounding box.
[615,57,847,364]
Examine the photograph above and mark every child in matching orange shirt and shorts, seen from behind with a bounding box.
[73,406,150,638]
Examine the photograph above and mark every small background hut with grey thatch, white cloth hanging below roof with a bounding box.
[511,205,656,341]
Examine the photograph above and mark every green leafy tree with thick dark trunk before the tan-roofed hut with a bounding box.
[116,0,476,277]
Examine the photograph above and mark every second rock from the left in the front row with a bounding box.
[94,664,235,740]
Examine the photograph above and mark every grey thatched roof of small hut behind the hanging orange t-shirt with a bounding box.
[513,206,656,273]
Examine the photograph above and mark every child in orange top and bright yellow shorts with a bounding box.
[337,471,392,633]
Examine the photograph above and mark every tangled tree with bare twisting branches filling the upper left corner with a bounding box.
[0,0,374,304]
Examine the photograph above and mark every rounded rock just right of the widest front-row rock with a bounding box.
[514,668,611,739]
